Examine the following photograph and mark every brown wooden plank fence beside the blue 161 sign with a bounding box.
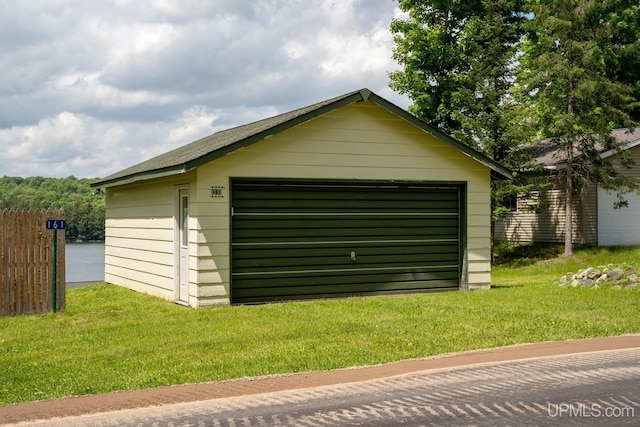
[0,209,66,316]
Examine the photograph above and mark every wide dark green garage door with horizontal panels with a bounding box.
[231,180,461,303]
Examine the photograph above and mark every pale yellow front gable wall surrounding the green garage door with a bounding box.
[194,102,491,305]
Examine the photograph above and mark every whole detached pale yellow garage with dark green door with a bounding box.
[92,89,510,307]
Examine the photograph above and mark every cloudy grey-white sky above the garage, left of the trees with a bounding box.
[0,0,410,178]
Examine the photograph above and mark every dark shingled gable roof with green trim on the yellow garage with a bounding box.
[91,89,511,188]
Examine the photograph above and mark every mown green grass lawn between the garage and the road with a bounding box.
[0,242,640,405]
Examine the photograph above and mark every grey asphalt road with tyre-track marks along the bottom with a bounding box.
[16,348,640,427]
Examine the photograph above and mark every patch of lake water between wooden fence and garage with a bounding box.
[65,242,104,289]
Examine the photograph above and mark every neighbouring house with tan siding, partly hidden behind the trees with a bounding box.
[494,129,640,246]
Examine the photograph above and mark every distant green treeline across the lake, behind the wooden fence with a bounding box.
[0,176,105,241]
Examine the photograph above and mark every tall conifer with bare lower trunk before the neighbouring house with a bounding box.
[518,0,638,256]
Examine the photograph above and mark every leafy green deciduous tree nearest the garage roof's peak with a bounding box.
[390,0,482,143]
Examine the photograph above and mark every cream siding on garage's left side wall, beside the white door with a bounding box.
[105,176,197,300]
